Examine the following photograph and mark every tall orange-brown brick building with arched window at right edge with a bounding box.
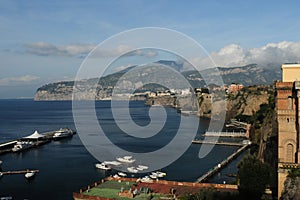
[276,64,300,198]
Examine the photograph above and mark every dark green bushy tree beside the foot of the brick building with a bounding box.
[238,155,270,199]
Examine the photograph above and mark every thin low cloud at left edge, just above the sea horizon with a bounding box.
[0,75,40,86]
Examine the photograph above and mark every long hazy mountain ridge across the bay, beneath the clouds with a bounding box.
[35,60,281,100]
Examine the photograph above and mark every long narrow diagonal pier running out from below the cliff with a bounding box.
[196,144,250,183]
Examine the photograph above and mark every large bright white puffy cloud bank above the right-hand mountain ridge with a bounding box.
[194,41,300,67]
